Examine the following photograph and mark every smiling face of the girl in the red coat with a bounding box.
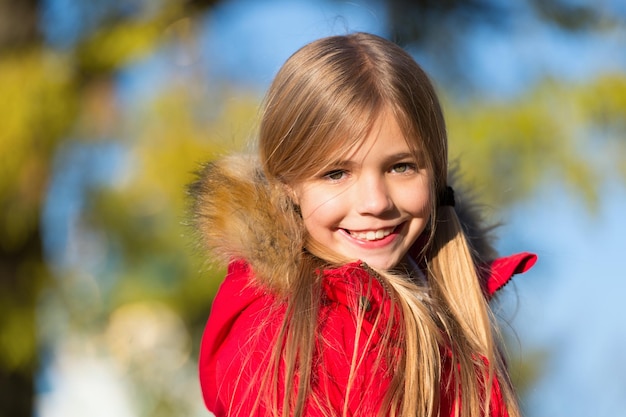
[292,112,432,269]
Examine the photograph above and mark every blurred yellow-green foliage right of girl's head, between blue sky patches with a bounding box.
[446,74,626,209]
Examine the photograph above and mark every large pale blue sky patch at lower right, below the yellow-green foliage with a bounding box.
[504,182,626,417]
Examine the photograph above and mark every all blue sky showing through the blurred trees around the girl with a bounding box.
[41,0,626,417]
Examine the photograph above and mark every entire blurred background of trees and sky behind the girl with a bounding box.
[0,0,626,417]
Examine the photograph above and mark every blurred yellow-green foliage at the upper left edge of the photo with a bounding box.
[0,49,76,250]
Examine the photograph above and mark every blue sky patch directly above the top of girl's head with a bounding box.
[203,0,387,87]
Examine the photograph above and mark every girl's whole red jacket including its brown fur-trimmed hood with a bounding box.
[191,157,536,417]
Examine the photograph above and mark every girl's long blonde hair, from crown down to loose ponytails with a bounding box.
[244,33,519,417]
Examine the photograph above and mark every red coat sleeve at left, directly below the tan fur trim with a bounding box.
[198,262,276,417]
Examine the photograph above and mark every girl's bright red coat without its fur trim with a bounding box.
[199,253,536,417]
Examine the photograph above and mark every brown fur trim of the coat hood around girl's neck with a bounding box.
[189,155,497,292]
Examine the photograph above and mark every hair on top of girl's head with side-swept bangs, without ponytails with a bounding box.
[259,31,447,188]
